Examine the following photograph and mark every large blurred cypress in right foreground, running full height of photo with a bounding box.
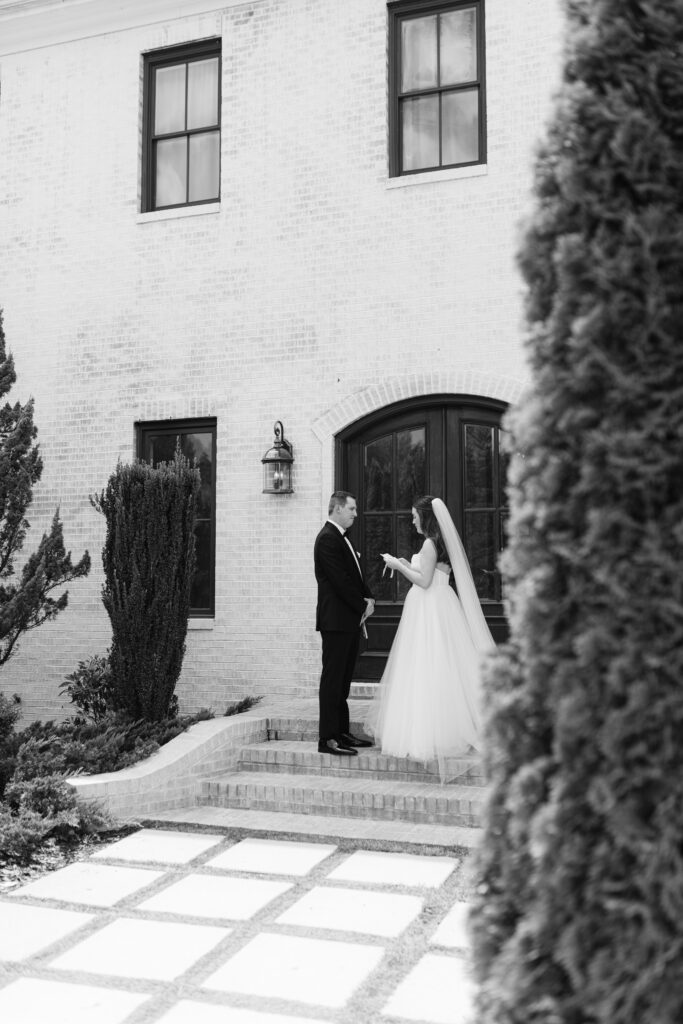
[473,0,683,1024]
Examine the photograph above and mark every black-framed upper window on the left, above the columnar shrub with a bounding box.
[142,39,220,211]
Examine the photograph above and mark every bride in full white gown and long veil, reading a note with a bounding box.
[365,496,496,778]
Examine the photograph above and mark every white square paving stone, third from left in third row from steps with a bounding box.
[203,934,384,1007]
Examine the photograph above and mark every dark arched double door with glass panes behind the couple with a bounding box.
[336,395,508,679]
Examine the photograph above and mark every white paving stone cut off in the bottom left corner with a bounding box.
[0,978,148,1024]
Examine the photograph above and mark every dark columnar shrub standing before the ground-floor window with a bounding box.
[92,451,200,722]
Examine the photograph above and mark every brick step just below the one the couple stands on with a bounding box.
[199,770,485,828]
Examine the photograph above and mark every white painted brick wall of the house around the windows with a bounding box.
[0,0,560,718]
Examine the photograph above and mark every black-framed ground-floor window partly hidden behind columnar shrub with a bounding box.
[137,419,216,617]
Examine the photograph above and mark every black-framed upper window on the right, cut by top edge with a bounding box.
[389,0,485,176]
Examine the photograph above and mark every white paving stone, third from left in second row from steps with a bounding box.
[278,887,422,937]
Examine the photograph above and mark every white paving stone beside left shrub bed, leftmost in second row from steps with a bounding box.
[11,861,164,906]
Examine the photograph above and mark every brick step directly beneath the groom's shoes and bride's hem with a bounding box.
[238,739,484,785]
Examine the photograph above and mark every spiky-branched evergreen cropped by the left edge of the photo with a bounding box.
[0,312,90,666]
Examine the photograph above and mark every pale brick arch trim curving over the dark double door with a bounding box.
[311,370,528,518]
